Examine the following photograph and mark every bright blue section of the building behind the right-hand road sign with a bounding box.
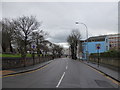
[82,35,109,60]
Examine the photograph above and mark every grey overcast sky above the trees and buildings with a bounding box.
[2,2,118,47]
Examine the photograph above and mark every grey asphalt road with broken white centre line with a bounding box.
[2,58,118,88]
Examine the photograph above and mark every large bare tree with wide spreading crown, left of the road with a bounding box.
[13,16,40,57]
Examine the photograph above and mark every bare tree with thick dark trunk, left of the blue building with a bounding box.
[67,29,81,59]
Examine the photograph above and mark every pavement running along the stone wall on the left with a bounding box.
[0,60,53,76]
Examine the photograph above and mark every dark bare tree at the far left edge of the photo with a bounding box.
[1,18,14,52]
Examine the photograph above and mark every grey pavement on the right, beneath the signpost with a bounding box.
[82,61,120,82]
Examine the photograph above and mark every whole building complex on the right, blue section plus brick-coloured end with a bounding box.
[82,34,120,60]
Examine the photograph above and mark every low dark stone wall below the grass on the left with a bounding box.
[2,56,52,70]
